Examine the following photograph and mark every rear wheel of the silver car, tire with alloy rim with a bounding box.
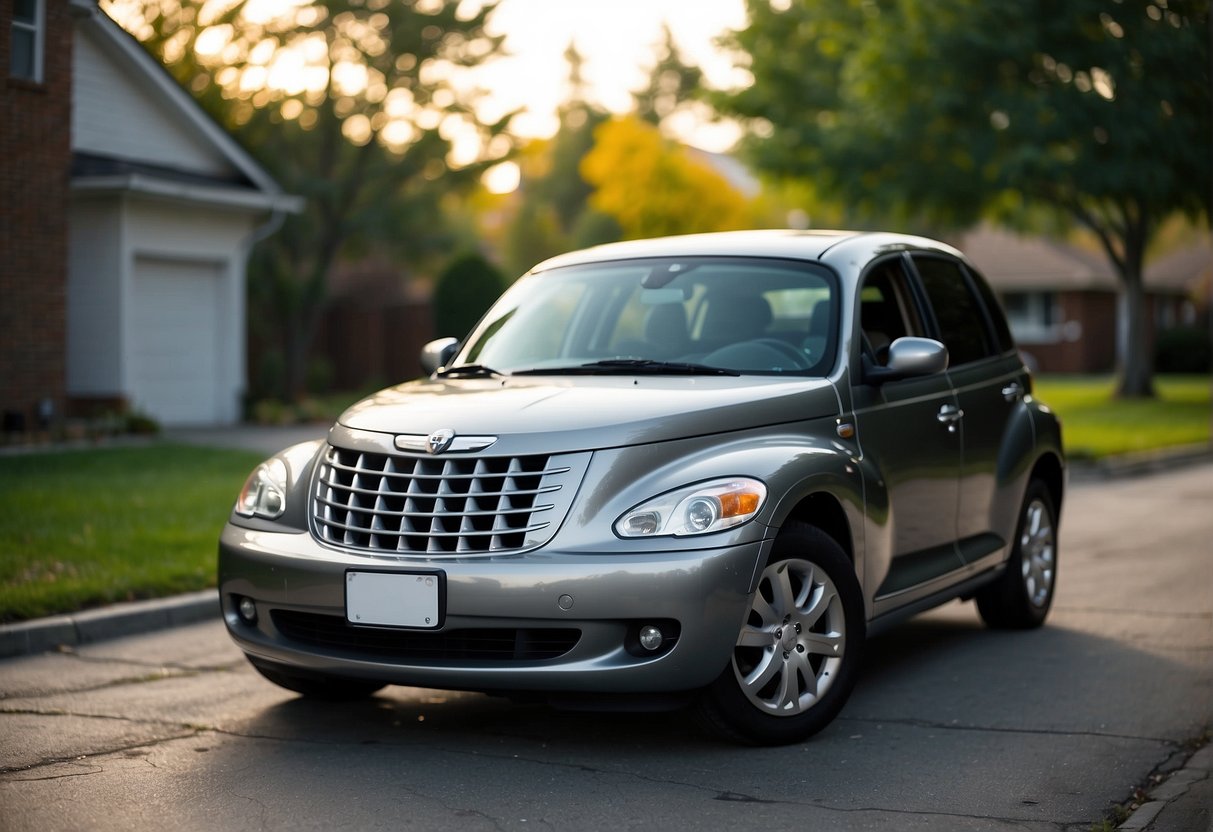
[976,479,1058,629]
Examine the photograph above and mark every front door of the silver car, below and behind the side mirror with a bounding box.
[853,255,963,606]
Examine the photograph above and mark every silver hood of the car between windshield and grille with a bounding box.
[338,376,838,451]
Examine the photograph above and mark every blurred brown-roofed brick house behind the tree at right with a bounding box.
[956,226,1213,372]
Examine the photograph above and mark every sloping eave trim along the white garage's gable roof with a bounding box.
[70,0,283,196]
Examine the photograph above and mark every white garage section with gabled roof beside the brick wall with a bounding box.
[67,4,302,426]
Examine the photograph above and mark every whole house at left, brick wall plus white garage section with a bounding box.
[0,0,301,427]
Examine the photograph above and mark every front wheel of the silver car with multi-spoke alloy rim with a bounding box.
[699,523,865,746]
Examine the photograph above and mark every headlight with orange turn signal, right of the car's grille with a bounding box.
[615,477,767,537]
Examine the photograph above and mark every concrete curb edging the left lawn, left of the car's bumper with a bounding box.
[0,589,220,659]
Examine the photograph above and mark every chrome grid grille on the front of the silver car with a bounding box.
[312,445,581,554]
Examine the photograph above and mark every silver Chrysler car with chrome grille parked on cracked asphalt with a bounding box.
[218,230,1066,745]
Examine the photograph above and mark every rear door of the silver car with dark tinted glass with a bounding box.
[912,253,1029,564]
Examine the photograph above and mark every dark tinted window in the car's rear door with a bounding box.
[913,256,1009,366]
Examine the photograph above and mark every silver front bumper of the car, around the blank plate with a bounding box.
[220,524,764,694]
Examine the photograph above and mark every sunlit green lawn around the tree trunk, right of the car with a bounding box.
[1036,376,1211,461]
